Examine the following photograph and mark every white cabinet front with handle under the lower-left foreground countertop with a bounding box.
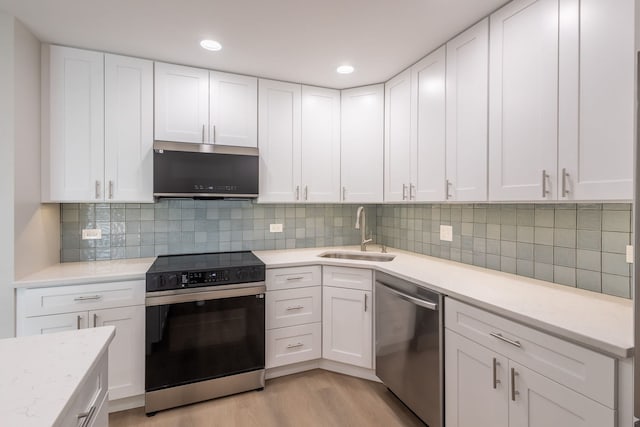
[55,353,108,427]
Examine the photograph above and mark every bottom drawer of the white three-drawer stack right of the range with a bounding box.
[266,323,322,368]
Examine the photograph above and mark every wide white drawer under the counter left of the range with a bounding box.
[18,280,145,317]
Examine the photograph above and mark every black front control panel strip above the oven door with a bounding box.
[147,267,265,292]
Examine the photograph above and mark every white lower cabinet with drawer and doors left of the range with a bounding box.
[17,280,145,409]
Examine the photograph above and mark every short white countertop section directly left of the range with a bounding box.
[13,258,155,288]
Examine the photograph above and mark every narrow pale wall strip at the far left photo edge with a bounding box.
[0,12,15,338]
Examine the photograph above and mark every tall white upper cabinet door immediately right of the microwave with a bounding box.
[258,79,301,202]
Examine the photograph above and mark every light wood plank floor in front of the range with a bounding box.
[109,369,424,427]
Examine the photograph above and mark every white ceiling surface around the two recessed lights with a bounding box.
[0,0,506,88]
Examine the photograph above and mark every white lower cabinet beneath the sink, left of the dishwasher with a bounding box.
[322,267,373,369]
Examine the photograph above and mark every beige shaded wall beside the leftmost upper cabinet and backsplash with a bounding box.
[14,20,60,279]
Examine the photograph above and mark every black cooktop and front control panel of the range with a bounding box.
[146,251,265,292]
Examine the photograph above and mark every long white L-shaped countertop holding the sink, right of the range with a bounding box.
[254,246,634,358]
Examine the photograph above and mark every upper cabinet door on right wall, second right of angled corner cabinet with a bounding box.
[405,46,446,201]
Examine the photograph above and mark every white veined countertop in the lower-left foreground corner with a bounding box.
[0,326,115,427]
